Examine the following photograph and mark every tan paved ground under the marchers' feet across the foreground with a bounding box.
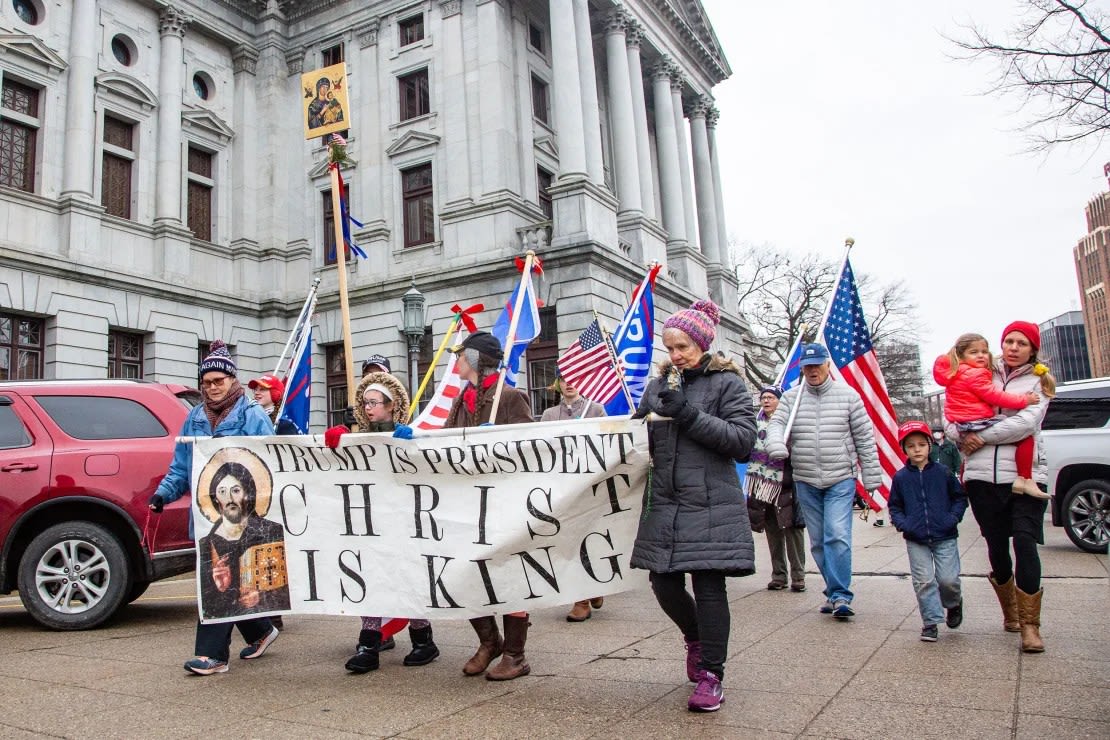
[0,515,1110,740]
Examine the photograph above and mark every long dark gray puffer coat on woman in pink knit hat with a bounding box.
[632,355,756,576]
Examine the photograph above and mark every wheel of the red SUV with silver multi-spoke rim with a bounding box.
[19,521,131,630]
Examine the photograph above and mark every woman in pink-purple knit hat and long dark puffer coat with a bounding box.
[632,301,756,712]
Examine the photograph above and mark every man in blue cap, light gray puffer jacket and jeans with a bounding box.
[767,344,882,620]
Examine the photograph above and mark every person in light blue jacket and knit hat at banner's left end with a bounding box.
[149,339,279,676]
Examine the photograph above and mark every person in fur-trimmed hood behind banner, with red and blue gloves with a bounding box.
[324,372,440,673]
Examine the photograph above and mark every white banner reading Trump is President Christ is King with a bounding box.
[192,417,648,622]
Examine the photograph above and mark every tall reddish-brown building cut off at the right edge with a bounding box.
[1073,171,1110,377]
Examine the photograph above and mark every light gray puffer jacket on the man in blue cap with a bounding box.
[767,377,882,490]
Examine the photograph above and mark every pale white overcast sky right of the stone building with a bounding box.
[703,0,1110,381]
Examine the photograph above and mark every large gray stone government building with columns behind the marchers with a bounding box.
[0,0,746,427]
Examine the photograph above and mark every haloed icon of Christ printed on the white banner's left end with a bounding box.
[196,447,290,619]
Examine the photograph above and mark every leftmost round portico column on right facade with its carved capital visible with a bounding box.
[605,8,642,213]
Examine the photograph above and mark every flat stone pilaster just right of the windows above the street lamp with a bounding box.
[437,0,473,209]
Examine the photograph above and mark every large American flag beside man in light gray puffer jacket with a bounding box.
[824,260,902,511]
